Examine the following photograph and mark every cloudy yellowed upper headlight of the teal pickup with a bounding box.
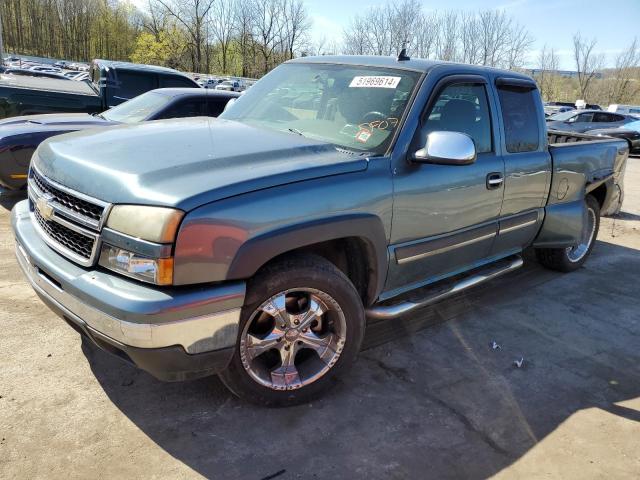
[107,205,184,243]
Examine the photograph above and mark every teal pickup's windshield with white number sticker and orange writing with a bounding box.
[220,64,420,155]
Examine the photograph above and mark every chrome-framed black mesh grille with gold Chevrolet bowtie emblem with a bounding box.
[28,167,110,266]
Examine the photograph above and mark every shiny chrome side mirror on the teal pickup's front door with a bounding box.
[412,132,476,165]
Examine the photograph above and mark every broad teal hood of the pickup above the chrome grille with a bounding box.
[34,117,368,211]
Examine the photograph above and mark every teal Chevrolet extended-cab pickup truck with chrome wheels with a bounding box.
[12,56,629,405]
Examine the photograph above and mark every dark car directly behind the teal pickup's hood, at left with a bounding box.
[0,88,239,190]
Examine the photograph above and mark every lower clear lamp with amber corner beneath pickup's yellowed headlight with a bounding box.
[99,244,173,285]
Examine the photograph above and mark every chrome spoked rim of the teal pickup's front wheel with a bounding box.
[240,288,347,390]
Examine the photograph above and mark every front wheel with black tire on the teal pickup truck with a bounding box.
[220,255,365,406]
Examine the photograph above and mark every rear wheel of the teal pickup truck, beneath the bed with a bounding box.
[536,195,600,272]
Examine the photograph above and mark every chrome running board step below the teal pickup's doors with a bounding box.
[366,255,524,320]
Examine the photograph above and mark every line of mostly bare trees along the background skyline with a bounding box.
[0,0,640,104]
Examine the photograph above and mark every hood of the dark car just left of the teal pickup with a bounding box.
[0,113,113,137]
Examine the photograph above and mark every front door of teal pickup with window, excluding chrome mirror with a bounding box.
[384,75,504,297]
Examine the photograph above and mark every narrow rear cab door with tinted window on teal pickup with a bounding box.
[492,78,551,255]
